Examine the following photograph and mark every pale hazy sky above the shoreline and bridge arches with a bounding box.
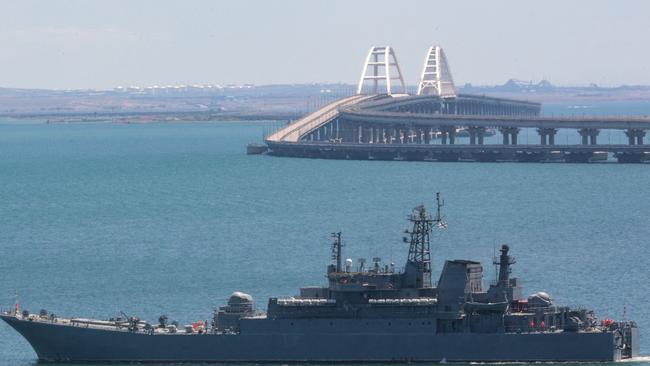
[0,0,650,89]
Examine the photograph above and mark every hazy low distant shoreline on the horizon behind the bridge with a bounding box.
[0,80,650,123]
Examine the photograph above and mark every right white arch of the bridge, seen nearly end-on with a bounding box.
[417,46,456,98]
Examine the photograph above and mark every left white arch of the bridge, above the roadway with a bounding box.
[357,46,406,95]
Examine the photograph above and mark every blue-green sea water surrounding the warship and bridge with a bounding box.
[0,102,650,366]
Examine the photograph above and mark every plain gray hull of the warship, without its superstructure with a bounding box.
[2,316,638,362]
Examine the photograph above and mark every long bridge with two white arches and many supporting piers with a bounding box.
[265,46,650,163]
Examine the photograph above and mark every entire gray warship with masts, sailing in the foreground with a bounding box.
[0,195,639,362]
